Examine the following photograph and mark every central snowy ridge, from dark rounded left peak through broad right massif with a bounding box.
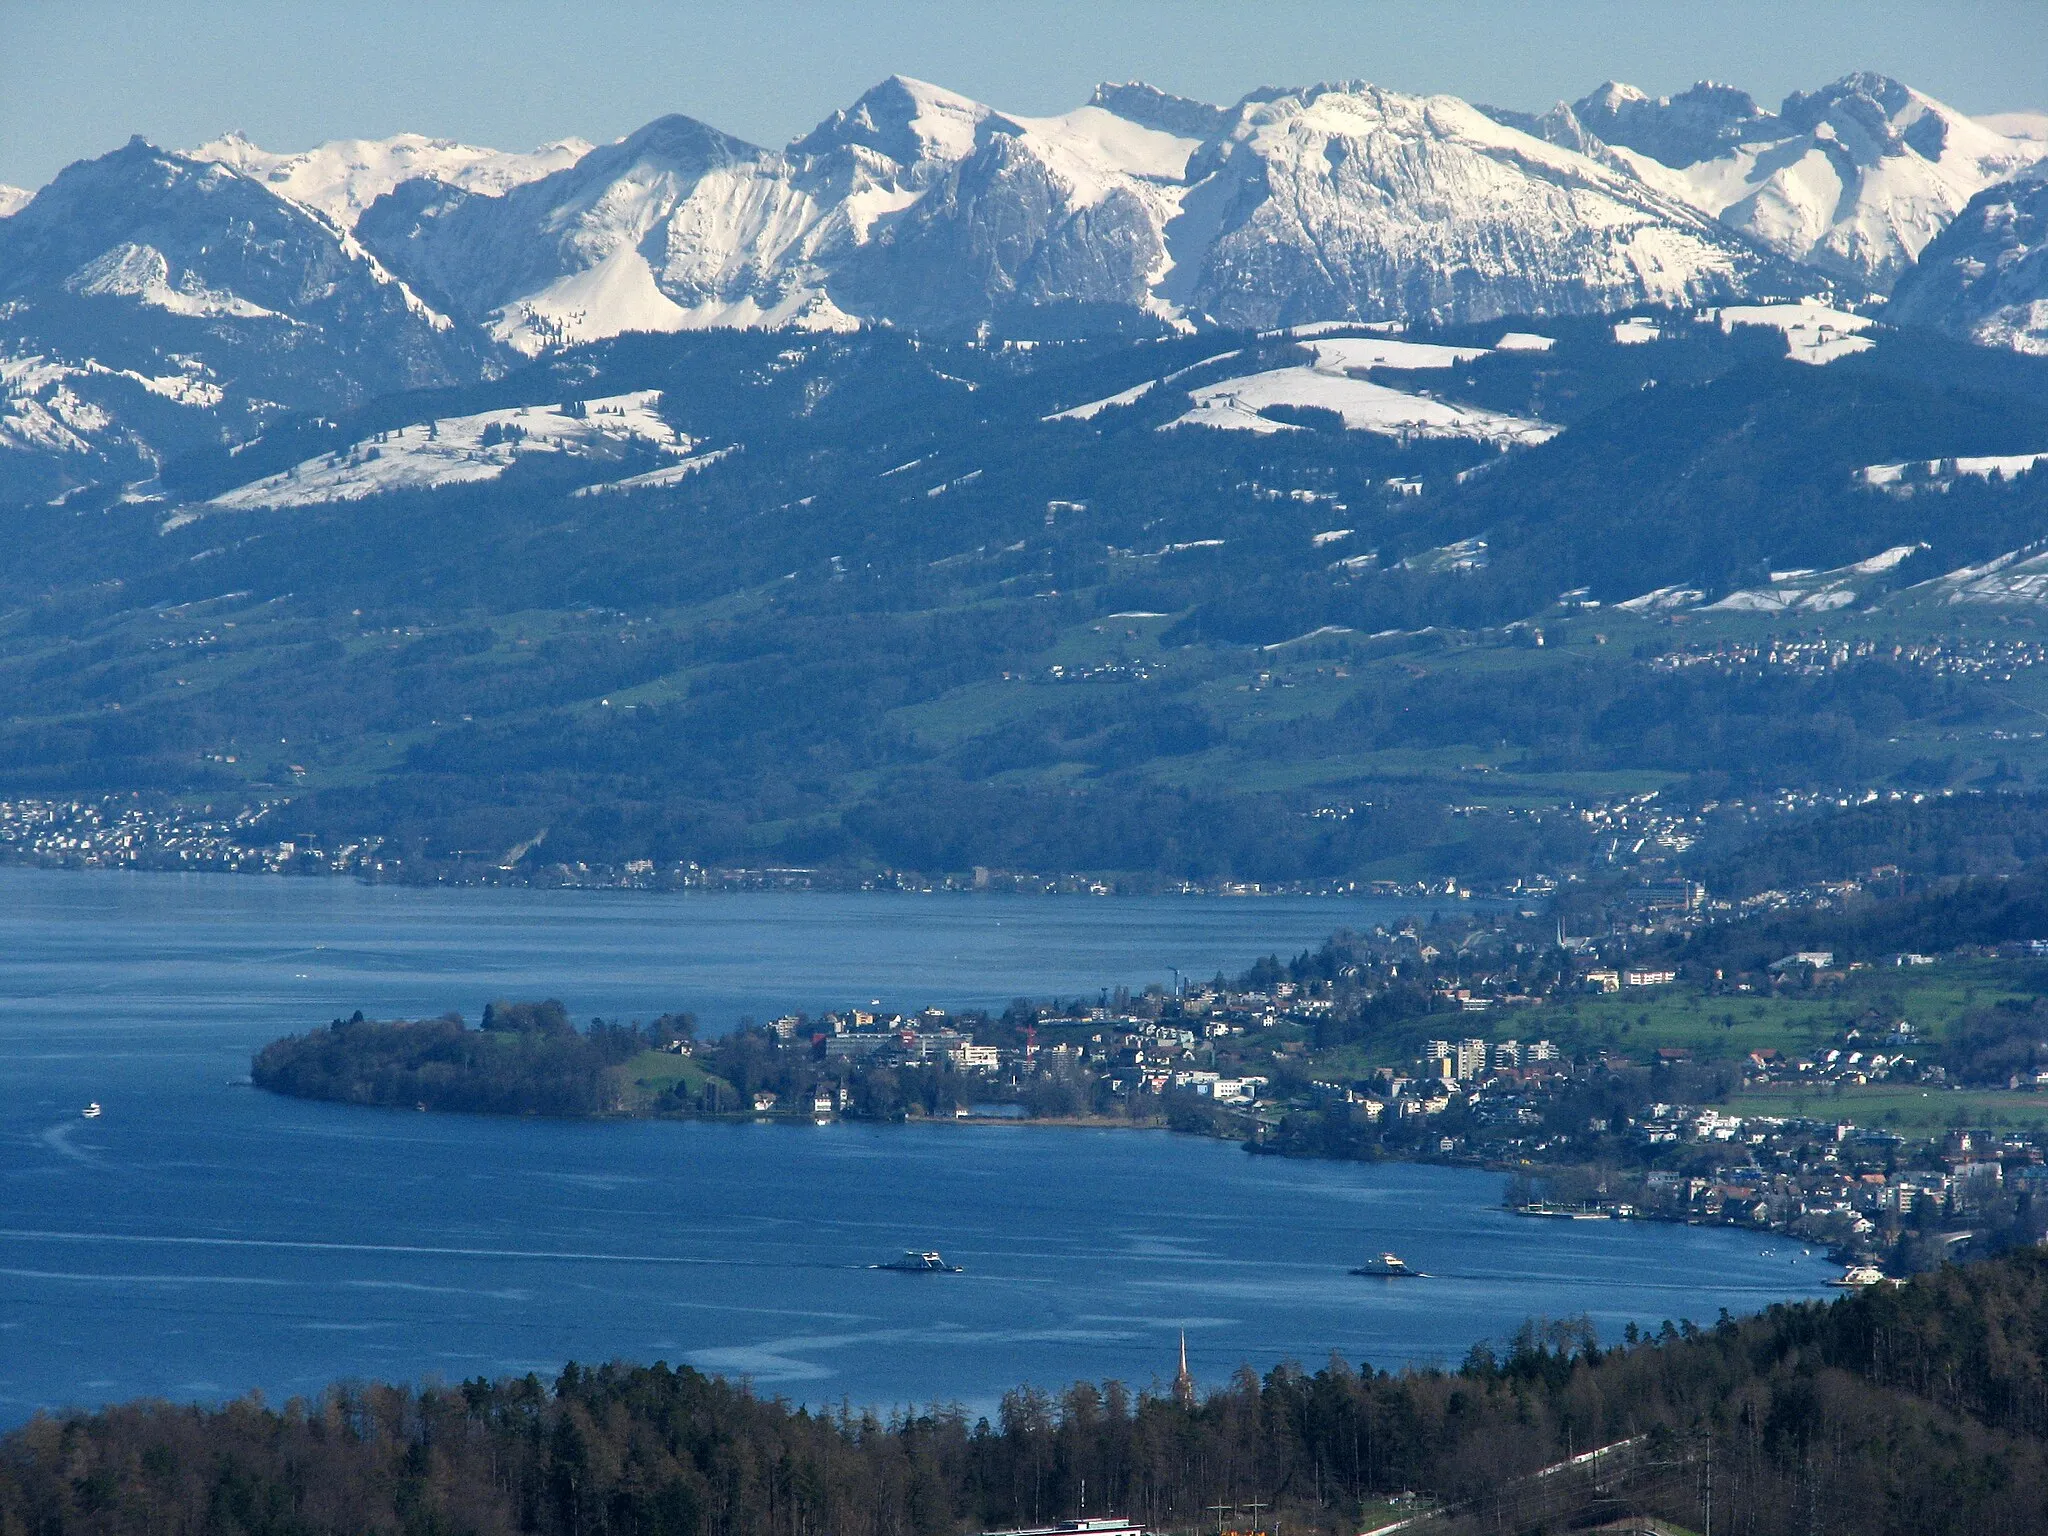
[356,78,1772,354]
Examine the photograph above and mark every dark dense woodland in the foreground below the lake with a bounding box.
[12,1251,2048,1536]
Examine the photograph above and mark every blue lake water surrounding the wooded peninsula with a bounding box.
[0,870,1831,1421]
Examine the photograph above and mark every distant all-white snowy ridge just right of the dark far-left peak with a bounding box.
[184,131,590,229]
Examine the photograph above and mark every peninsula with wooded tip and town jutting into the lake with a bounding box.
[256,889,2048,1284]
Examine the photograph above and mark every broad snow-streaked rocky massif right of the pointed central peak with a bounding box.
[1159,82,1765,328]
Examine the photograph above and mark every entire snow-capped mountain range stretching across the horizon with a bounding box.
[0,76,2048,501]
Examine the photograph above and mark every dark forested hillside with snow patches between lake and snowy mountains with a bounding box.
[12,313,2048,885]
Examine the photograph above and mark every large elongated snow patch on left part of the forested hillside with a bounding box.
[205,389,696,512]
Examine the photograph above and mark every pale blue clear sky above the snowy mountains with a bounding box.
[0,0,2048,186]
